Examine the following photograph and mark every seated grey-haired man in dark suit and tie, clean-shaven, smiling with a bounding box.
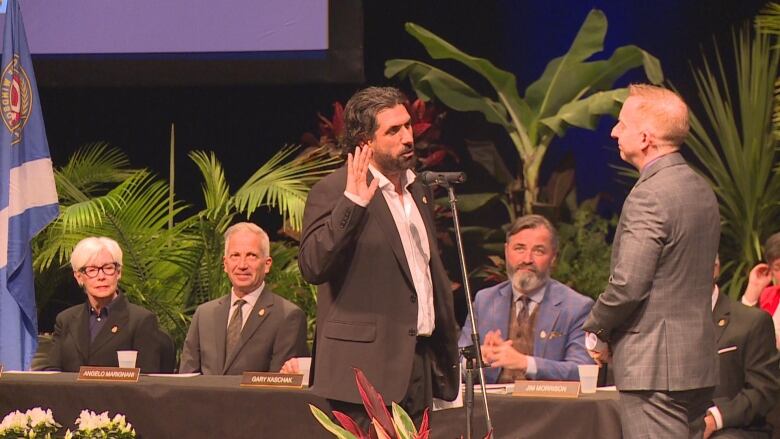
[179,223,309,375]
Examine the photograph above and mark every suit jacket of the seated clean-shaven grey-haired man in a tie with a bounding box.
[179,285,309,375]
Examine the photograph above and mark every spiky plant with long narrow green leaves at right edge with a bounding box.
[686,28,780,298]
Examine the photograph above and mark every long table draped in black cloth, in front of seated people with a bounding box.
[0,372,620,439]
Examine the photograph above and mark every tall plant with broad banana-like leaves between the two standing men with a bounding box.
[385,9,663,219]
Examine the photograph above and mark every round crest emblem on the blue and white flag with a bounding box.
[0,55,33,145]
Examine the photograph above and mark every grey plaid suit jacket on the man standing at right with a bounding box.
[583,153,720,391]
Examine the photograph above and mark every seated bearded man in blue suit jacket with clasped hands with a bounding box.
[458,215,593,383]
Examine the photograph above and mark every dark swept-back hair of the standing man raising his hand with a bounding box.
[340,87,409,155]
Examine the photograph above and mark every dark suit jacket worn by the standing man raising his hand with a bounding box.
[298,167,459,403]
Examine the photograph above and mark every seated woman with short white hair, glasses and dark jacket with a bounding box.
[47,237,164,373]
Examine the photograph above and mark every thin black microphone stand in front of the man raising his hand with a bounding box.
[436,178,496,439]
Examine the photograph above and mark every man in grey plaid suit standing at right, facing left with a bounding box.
[583,85,720,438]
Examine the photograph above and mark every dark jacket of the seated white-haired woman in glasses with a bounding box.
[46,293,162,373]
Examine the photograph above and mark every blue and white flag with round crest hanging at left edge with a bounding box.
[0,0,59,370]
